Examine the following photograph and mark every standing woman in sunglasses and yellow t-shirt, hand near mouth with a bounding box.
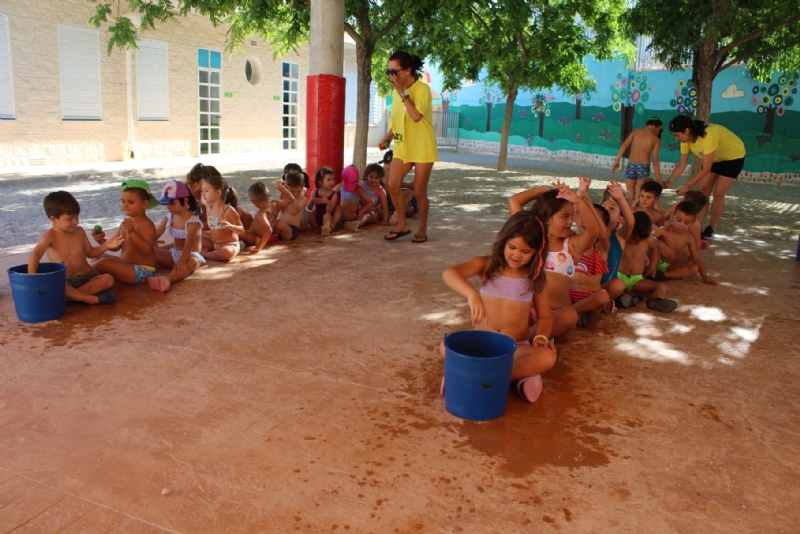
[378,52,439,243]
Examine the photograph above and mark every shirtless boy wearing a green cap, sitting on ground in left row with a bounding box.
[92,180,158,285]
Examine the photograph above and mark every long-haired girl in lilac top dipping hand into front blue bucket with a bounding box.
[440,211,556,402]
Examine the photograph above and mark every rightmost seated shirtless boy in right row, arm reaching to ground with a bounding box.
[653,200,717,286]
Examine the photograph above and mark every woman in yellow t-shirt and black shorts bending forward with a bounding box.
[665,115,745,239]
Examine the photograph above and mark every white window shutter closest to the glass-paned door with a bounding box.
[136,39,169,121]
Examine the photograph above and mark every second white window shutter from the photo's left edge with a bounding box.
[58,24,103,120]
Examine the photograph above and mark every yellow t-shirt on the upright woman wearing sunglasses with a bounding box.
[390,80,439,163]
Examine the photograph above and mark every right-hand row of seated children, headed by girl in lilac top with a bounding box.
[441,177,717,402]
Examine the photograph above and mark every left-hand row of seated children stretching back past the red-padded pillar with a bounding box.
[28,151,413,304]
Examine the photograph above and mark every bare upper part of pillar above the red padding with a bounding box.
[308,0,344,76]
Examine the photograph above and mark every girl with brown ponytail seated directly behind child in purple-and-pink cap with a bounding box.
[201,175,244,261]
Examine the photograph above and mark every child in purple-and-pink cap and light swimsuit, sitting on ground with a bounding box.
[147,180,206,291]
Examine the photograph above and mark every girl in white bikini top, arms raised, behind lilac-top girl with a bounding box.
[509,178,600,341]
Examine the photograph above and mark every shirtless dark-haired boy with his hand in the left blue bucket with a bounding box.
[28,191,122,304]
